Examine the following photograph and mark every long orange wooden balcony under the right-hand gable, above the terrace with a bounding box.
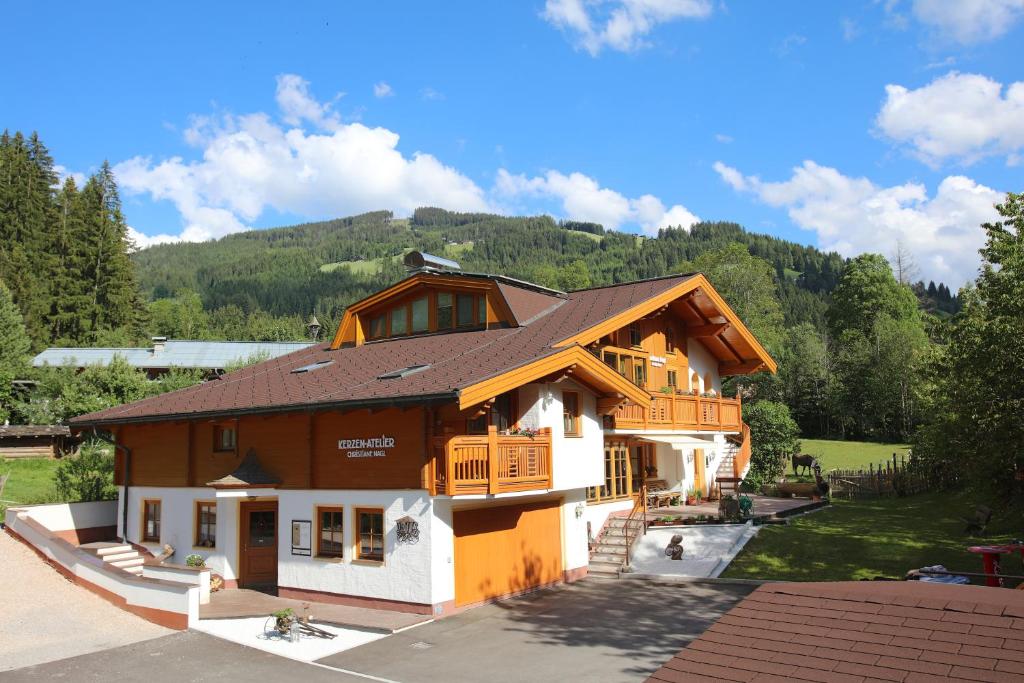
[606,393,742,432]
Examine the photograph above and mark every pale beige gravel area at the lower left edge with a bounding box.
[0,530,174,671]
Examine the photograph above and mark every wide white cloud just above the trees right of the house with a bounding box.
[715,161,1005,287]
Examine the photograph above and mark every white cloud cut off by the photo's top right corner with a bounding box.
[913,0,1024,45]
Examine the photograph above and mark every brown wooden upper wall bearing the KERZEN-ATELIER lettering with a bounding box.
[115,408,426,488]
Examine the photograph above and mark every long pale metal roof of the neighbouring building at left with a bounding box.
[32,337,311,378]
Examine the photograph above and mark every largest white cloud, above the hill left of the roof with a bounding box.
[114,75,489,244]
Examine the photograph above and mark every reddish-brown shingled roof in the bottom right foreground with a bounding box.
[648,582,1024,683]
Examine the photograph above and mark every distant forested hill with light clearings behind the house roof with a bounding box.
[133,209,843,335]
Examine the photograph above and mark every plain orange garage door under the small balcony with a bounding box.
[453,501,562,605]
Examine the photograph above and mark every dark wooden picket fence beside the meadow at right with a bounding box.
[828,453,955,499]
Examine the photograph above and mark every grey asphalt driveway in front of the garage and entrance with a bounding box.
[0,580,755,683]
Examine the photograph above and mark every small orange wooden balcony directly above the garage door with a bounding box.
[430,427,551,496]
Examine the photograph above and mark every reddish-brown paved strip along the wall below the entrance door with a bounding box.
[199,588,433,633]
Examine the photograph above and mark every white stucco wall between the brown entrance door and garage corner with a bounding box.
[278,490,437,604]
